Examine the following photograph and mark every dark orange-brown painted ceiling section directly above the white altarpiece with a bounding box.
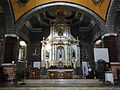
[44,9,80,25]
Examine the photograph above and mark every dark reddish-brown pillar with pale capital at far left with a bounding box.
[3,34,19,63]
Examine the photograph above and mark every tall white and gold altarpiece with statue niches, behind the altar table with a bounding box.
[41,23,80,69]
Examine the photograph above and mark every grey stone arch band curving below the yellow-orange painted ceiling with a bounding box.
[16,2,106,34]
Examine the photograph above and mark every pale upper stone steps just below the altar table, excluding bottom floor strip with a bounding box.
[18,79,103,87]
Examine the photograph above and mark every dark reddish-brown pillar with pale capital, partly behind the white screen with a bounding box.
[102,33,118,62]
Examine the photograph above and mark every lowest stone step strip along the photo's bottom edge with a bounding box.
[0,87,120,90]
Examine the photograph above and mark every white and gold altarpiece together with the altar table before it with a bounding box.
[40,11,81,79]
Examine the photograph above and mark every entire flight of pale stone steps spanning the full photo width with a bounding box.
[0,79,120,90]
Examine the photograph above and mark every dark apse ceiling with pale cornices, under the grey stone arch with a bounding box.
[26,10,95,32]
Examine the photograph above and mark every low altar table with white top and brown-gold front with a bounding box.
[47,69,74,79]
